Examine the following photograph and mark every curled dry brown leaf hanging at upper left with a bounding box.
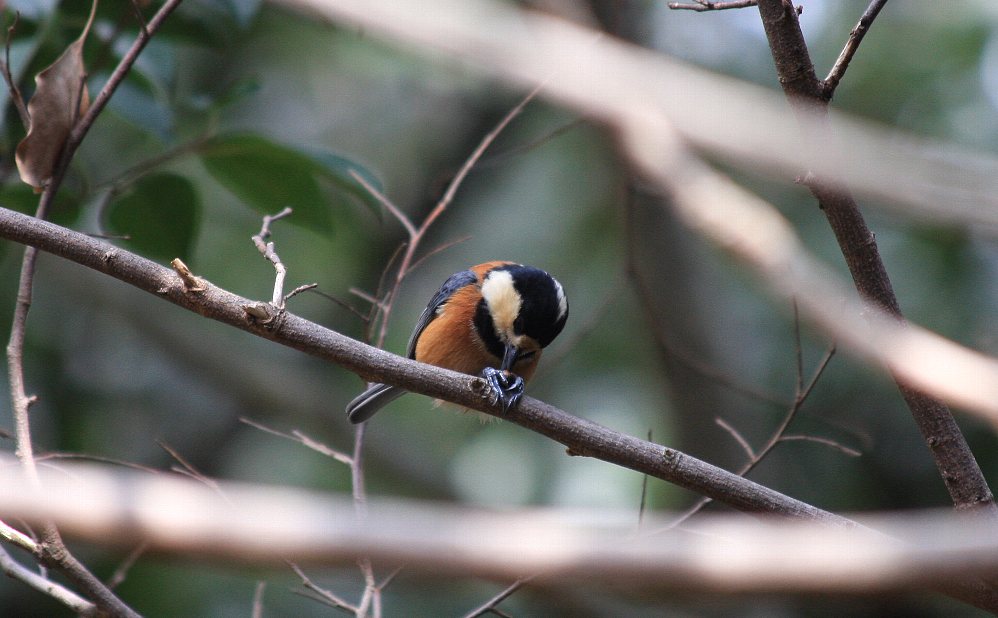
[15,0,97,191]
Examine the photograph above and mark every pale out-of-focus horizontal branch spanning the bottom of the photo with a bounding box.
[7,464,998,601]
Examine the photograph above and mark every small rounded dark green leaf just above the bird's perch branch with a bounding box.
[107,174,201,261]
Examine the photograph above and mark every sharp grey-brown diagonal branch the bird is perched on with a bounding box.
[0,209,849,525]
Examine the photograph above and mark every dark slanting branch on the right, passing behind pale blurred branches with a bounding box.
[759,0,998,521]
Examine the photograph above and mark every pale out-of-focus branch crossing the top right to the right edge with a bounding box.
[271,0,998,236]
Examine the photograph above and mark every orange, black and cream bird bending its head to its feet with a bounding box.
[347,262,568,423]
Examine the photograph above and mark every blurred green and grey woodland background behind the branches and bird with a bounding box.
[0,0,998,616]
